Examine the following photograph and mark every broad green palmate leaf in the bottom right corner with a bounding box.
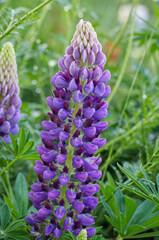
[101,189,159,239]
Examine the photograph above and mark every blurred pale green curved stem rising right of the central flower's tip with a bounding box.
[108,3,135,102]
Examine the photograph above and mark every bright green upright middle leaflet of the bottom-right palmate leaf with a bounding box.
[124,196,136,224]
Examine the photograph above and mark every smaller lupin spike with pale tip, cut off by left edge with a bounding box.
[0,42,21,144]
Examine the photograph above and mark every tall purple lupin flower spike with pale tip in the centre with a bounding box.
[26,20,110,240]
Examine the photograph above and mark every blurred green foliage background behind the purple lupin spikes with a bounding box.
[0,0,159,239]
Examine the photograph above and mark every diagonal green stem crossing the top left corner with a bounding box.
[0,0,52,40]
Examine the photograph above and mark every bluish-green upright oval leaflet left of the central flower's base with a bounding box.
[15,173,28,216]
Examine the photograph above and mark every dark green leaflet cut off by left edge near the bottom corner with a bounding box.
[0,204,11,230]
